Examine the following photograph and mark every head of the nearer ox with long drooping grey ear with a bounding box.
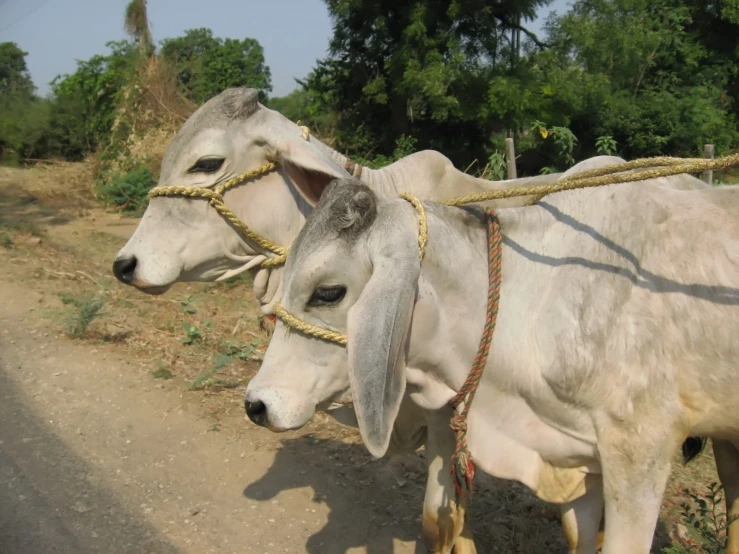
[246,179,420,456]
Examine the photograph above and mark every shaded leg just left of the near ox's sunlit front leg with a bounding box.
[560,475,603,554]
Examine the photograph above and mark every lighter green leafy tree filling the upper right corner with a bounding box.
[550,0,739,158]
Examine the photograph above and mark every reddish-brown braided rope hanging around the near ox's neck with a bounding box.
[449,210,503,506]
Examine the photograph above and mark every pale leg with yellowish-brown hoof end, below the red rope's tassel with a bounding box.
[423,407,477,554]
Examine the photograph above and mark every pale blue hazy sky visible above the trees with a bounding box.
[0,0,571,96]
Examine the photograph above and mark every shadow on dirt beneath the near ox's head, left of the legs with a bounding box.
[243,435,426,554]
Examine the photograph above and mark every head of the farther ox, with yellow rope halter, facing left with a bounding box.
[113,88,346,304]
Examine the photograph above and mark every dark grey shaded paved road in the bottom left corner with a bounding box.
[0,362,177,554]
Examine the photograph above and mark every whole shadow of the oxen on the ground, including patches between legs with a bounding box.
[243,435,688,554]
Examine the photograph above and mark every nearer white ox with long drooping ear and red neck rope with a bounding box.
[246,180,739,554]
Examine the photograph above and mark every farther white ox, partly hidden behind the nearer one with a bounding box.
[114,89,716,554]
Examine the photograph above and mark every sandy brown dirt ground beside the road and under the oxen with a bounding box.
[0,172,723,554]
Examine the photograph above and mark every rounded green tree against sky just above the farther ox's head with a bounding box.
[161,28,272,104]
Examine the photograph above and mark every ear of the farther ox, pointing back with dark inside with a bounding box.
[268,120,349,207]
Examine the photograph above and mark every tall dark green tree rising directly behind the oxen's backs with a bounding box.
[300,0,549,161]
